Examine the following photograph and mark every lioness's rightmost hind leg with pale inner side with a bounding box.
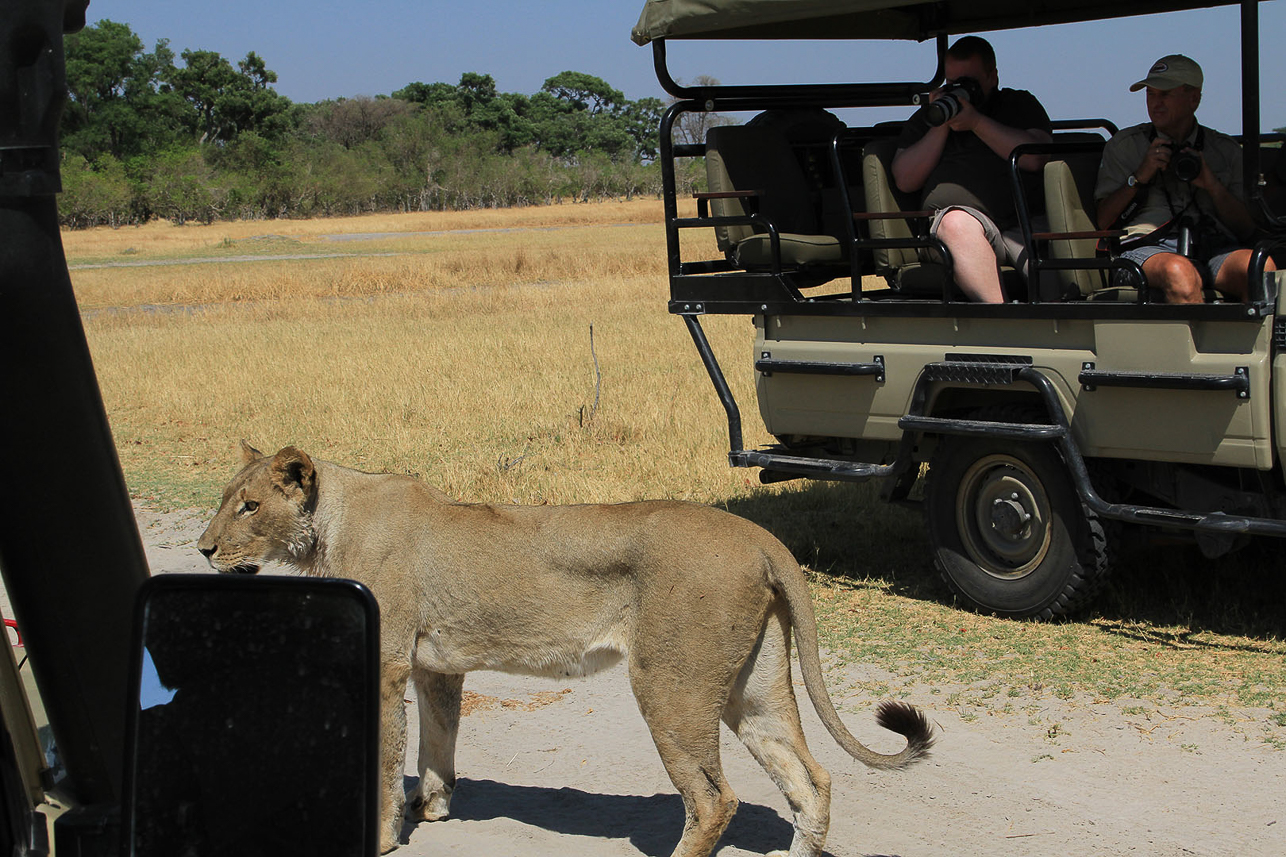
[724,605,831,857]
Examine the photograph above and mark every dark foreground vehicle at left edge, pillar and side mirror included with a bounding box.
[0,0,378,857]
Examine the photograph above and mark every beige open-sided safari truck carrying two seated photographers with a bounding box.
[633,0,1286,619]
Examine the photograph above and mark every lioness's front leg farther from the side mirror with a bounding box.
[406,669,464,821]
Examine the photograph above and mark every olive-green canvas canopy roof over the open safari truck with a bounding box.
[631,0,1255,45]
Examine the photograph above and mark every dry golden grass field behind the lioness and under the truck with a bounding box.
[63,201,1286,746]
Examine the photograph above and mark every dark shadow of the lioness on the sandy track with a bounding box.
[404,777,848,857]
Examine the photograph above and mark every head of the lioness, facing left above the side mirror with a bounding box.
[197,440,324,574]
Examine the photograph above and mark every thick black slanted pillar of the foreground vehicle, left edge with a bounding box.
[0,0,148,803]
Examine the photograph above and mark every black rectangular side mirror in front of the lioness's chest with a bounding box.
[121,574,379,857]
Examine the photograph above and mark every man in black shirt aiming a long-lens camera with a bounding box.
[892,36,1053,304]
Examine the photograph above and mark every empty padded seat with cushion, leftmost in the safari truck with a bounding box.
[706,125,847,273]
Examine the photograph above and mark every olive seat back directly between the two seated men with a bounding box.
[1043,135,1107,297]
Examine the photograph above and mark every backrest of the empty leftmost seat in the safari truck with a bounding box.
[706,125,818,252]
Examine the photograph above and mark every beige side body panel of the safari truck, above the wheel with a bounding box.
[755,303,1286,471]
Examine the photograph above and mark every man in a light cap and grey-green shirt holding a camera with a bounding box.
[1094,54,1274,304]
